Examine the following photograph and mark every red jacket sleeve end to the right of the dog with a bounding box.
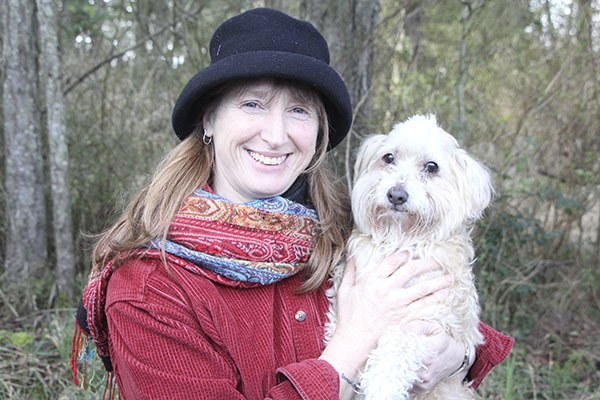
[467,322,515,388]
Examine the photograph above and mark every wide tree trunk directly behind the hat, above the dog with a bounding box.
[301,0,380,188]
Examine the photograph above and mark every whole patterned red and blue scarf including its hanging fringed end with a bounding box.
[71,189,317,384]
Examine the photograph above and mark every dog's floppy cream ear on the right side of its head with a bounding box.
[454,148,494,223]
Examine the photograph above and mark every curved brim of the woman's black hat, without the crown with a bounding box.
[172,51,352,149]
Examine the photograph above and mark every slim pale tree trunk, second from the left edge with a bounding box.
[37,0,75,298]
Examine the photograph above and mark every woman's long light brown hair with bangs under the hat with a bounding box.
[92,79,352,292]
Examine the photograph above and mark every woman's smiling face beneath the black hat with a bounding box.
[203,81,319,202]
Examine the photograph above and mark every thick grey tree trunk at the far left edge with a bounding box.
[0,0,47,283]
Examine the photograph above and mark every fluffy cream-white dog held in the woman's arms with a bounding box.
[325,116,493,400]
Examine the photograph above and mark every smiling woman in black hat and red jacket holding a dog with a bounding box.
[75,9,512,399]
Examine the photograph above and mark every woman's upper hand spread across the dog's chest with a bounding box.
[320,252,451,396]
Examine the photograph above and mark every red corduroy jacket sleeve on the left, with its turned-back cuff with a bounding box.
[106,272,339,400]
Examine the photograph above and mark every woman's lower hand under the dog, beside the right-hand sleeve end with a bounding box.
[406,320,475,394]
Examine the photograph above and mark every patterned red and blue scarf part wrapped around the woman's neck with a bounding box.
[147,190,317,285]
